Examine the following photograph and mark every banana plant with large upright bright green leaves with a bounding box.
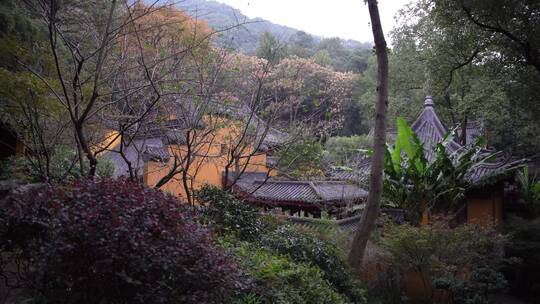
[384,118,492,224]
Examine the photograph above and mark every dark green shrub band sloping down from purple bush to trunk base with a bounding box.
[196,187,365,303]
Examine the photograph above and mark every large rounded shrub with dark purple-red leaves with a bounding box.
[0,180,241,303]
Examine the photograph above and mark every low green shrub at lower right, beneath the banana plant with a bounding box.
[382,225,507,304]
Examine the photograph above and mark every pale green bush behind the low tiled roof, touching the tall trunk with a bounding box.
[324,135,372,166]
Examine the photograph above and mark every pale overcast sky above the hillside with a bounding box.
[217,0,410,42]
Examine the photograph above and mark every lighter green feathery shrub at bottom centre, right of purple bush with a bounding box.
[226,238,351,304]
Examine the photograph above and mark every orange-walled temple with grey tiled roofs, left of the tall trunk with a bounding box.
[104,101,367,211]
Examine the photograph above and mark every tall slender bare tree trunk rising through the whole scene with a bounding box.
[349,0,388,269]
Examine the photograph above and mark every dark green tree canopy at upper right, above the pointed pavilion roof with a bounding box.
[386,0,540,156]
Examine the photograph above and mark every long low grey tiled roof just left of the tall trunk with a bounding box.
[229,172,367,204]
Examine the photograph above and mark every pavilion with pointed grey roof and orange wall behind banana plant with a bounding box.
[330,96,523,223]
